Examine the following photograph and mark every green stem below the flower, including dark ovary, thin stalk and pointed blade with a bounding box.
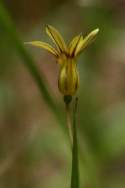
[64,96,79,188]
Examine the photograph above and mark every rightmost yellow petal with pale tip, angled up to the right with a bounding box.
[75,28,99,56]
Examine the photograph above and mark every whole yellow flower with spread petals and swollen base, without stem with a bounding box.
[26,25,99,96]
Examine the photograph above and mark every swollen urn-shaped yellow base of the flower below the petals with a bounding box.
[58,58,79,96]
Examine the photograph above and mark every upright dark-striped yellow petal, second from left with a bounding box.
[46,25,67,52]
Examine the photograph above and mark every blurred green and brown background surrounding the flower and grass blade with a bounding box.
[0,0,125,188]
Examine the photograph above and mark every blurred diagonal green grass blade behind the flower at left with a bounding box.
[0,2,64,127]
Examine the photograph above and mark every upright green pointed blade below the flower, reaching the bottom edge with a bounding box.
[71,98,79,188]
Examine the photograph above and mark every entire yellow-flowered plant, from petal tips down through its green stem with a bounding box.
[25,25,99,188]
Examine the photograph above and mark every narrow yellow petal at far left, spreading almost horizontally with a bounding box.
[24,41,58,56]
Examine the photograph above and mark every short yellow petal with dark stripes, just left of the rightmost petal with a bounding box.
[68,34,83,56]
